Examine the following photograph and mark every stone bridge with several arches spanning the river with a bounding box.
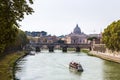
[30,43,91,52]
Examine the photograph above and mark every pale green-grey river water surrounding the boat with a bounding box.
[15,50,120,80]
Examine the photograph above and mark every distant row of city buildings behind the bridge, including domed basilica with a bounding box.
[25,24,102,44]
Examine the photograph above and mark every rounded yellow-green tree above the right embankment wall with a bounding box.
[102,20,120,51]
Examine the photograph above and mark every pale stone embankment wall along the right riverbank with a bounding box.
[88,44,120,63]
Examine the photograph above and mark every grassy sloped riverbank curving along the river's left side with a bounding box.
[0,51,26,80]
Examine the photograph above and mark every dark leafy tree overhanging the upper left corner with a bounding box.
[0,0,33,53]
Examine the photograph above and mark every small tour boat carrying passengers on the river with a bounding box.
[69,62,83,72]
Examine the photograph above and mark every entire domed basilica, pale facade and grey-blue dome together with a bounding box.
[66,24,87,44]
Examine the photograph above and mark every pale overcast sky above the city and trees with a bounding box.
[20,0,120,35]
